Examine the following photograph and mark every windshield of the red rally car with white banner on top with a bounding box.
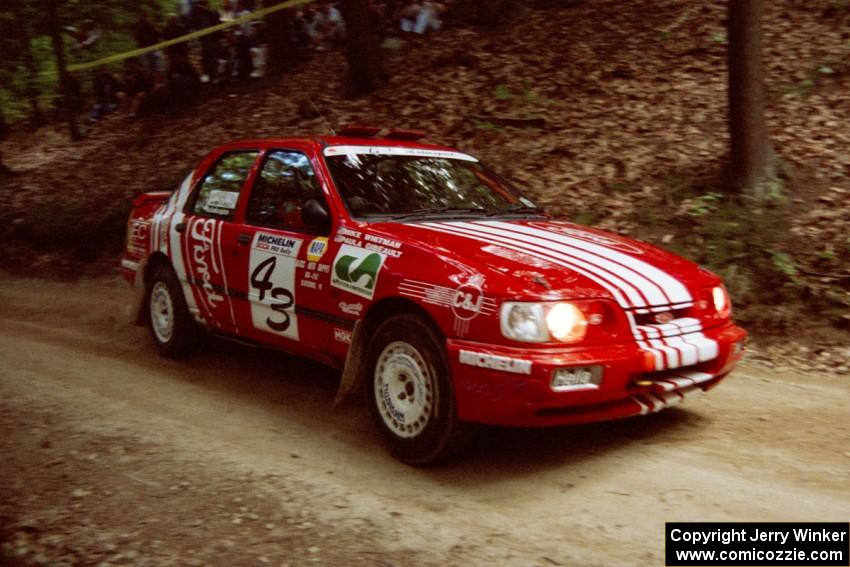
[325,148,537,220]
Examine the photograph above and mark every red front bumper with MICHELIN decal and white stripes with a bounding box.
[447,323,746,427]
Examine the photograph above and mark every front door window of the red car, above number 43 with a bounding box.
[245,150,324,231]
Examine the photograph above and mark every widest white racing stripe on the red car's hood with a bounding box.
[476,221,693,305]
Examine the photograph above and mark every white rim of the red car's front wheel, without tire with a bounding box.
[373,341,435,439]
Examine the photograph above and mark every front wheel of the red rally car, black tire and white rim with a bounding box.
[366,313,476,465]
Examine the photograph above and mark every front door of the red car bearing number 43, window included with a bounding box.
[237,149,330,357]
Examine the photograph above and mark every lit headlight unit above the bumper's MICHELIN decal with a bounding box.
[500,302,587,343]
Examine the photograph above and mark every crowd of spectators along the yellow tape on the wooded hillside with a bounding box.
[83,0,445,121]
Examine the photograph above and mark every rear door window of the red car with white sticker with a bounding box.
[192,150,259,220]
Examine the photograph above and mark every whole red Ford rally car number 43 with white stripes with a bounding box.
[121,128,746,463]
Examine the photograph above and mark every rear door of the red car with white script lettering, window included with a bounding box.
[177,149,260,334]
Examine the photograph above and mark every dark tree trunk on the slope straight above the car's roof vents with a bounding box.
[340,0,385,97]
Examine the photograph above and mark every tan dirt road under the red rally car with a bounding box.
[0,278,850,566]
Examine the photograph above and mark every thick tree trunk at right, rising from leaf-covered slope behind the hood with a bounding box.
[728,0,775,192]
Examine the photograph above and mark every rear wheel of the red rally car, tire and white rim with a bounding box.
[147,264,198,358]
